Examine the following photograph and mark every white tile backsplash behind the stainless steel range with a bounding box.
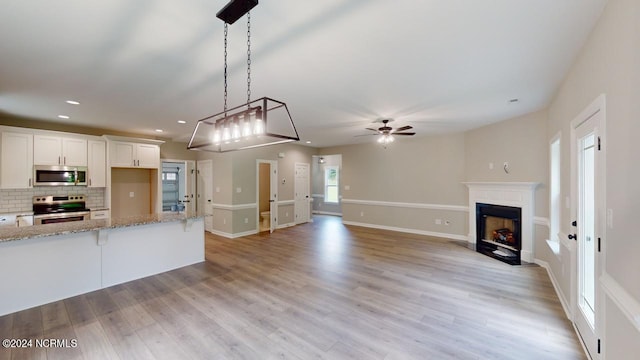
[0,186,105,214]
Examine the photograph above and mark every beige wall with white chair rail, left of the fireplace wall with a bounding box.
[321,134,468,239]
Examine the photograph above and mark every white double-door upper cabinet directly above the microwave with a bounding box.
[33,134,87,166]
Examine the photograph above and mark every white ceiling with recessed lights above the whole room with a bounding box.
[0,0,606,147]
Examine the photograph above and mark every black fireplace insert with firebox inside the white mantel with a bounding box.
[476,203,522,265]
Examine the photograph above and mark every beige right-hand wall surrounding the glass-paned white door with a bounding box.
[543,0,640,359]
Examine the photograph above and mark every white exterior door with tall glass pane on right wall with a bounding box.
[570,94,605,359]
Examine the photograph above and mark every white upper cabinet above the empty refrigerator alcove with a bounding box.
[110,141,160,169]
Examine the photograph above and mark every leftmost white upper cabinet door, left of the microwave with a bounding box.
[0,132,33,189]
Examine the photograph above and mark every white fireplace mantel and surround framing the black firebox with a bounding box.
[463,182,539,262]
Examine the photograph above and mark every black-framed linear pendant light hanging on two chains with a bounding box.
[187,0,300,152]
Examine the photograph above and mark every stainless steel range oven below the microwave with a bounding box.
[33,195,91,225]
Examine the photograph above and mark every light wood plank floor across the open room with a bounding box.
[0,216,586,360]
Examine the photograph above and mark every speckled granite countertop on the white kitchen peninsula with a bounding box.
[0,211,209,243]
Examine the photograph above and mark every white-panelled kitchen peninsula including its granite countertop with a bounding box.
[0,213,204,316]
